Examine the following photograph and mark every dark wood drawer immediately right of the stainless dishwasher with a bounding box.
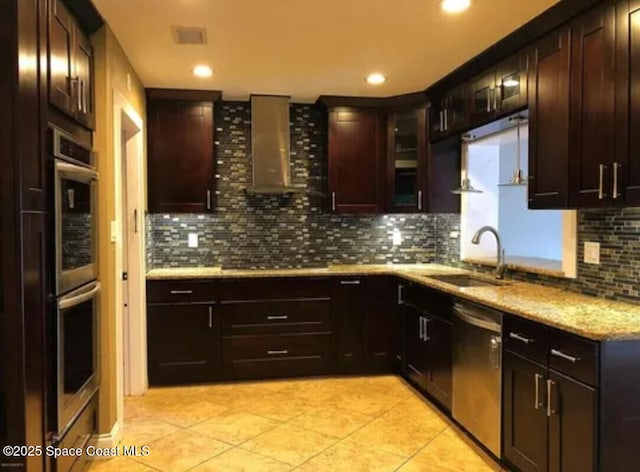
[502,316,549,365]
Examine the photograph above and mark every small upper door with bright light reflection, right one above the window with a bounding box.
[496,52,529,114]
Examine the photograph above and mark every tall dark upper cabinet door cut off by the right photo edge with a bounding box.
[612,0,640,205]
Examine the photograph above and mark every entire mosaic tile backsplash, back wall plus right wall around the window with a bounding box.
[147,102,640,303]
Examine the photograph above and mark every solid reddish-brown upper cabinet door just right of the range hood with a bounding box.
[329,108,385,213]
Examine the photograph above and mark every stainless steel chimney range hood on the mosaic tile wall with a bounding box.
[246,95,305,194]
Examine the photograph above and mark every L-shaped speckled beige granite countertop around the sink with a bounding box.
[147,264,640,341]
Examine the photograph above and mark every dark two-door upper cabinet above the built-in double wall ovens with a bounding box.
[48,0,95,130]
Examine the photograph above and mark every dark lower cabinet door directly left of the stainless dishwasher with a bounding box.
[425,318,453,410]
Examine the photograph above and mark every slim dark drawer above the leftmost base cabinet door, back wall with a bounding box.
[147,280,218,303]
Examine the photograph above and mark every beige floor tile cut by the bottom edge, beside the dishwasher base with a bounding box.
[413,428,501,472]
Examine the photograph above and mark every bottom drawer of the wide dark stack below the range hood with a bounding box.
[222,334,332,379]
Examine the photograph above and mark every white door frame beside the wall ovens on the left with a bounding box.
[112,90,148,430]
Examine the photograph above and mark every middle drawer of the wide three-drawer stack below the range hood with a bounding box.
[219,300,331,336]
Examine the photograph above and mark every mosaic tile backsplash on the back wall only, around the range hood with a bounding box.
[147,102,436,269]
